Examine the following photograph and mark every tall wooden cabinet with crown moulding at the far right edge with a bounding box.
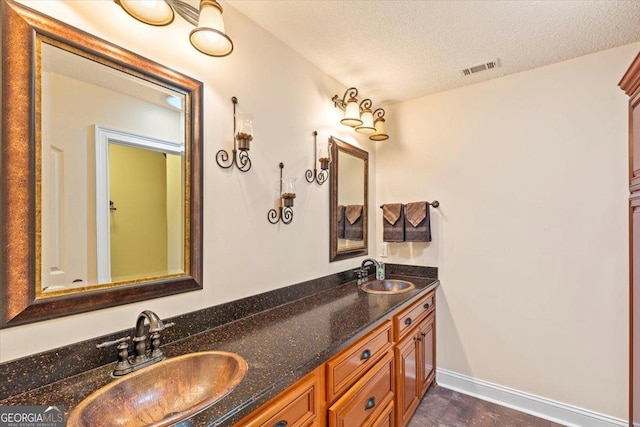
[619,54,640,427]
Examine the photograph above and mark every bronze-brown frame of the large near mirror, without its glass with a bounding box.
[0,0,203,328]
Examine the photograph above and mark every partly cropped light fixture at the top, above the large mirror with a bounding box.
[113,0,233,57]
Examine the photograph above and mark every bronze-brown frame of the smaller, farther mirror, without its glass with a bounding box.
[329,136,369,262]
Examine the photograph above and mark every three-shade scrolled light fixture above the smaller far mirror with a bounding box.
[331,87,389,141]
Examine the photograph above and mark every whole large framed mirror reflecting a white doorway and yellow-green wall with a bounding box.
[0,0,202,328]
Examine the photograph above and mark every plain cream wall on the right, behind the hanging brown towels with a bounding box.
[376,44,640,419]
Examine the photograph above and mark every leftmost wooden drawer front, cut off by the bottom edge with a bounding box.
[236,371,319,427]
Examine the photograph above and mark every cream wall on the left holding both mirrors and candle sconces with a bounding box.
[0,0,375,361]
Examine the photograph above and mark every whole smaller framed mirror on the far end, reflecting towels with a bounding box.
[329,137,369,261]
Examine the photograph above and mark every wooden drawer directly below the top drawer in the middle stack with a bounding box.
[329,352,394,427]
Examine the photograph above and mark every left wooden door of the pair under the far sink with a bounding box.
[395,330,420,427]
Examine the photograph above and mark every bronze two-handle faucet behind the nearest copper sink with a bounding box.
[96,310,174,377]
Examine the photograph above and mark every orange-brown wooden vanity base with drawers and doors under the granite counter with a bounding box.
[236,291,436,427]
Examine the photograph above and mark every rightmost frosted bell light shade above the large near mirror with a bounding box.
[189,0,233,57]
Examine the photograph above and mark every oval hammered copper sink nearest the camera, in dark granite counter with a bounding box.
[67,351,247,427]
